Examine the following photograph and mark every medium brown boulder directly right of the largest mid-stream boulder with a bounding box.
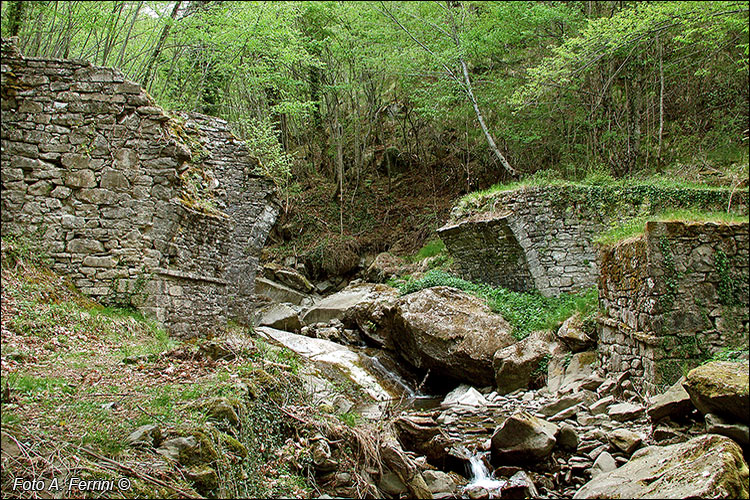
[492,331,552,394]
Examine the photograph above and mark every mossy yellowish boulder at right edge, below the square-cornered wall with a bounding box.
[683,361,750,424]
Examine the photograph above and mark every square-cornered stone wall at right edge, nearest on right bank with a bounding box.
[598,222,748,393]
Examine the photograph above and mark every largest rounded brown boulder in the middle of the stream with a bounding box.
[390,286,516,386]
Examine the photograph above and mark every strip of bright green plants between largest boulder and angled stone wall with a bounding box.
[394,270,598,339]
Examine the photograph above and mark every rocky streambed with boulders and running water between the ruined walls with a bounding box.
[256,264,750,498]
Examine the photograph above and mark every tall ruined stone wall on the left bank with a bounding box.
[1,40,279,337]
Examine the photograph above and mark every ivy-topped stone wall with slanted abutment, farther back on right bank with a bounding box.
[438,186,748,296]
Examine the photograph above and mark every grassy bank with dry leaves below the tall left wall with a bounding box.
[0,239,322,498]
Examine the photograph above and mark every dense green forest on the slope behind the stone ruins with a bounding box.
[2,1,748,262]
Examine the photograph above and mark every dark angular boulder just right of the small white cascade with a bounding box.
[491,411,558,465]
